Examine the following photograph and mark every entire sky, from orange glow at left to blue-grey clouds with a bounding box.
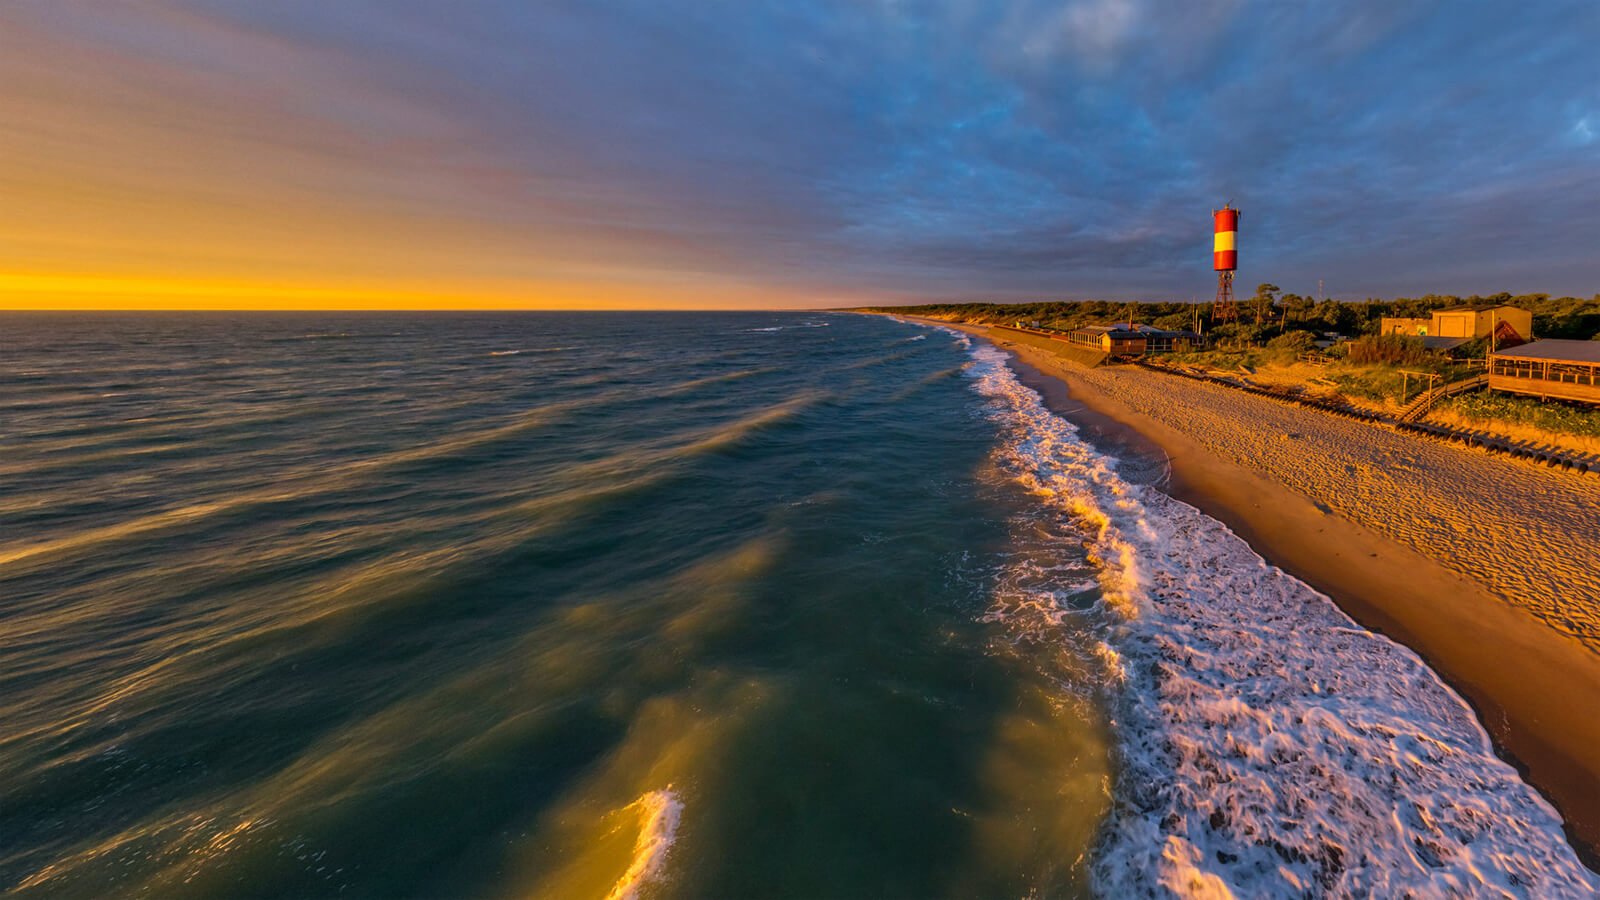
[0,0,1600,309]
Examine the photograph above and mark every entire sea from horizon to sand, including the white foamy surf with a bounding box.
[0,312,1600,900]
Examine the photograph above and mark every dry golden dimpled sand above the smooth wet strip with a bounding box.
[1075,367,1600,652]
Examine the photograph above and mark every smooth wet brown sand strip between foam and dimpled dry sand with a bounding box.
[906,317,1600,868]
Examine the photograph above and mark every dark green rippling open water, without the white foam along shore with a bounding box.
[0,314,1109,897]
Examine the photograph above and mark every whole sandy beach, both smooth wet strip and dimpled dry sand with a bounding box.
[939,322,1600,865]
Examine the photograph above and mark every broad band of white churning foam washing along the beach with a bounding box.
[970,339,1600,897]
